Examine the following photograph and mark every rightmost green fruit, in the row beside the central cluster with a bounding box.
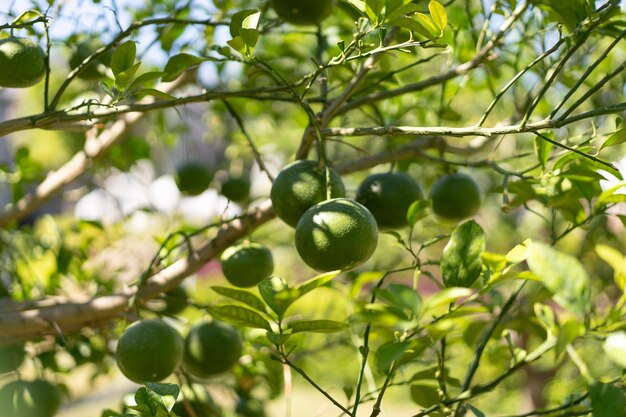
[429,173,481,221]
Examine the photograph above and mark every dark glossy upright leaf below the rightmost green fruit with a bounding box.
[441,220,486,288]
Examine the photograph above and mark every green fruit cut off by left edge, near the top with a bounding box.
[0,37,46,88]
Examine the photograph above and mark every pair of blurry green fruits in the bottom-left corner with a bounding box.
[0,343,61,417]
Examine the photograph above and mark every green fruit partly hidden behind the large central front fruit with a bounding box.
[270,160,346,227]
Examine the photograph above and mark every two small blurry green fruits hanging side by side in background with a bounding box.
[174,161,250,203]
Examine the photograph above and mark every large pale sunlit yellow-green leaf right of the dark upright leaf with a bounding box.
[527,242,591,316]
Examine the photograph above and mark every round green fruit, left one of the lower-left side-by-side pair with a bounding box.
[115,319,183,384]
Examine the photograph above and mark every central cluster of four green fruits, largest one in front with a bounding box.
[270,161,480,271]
